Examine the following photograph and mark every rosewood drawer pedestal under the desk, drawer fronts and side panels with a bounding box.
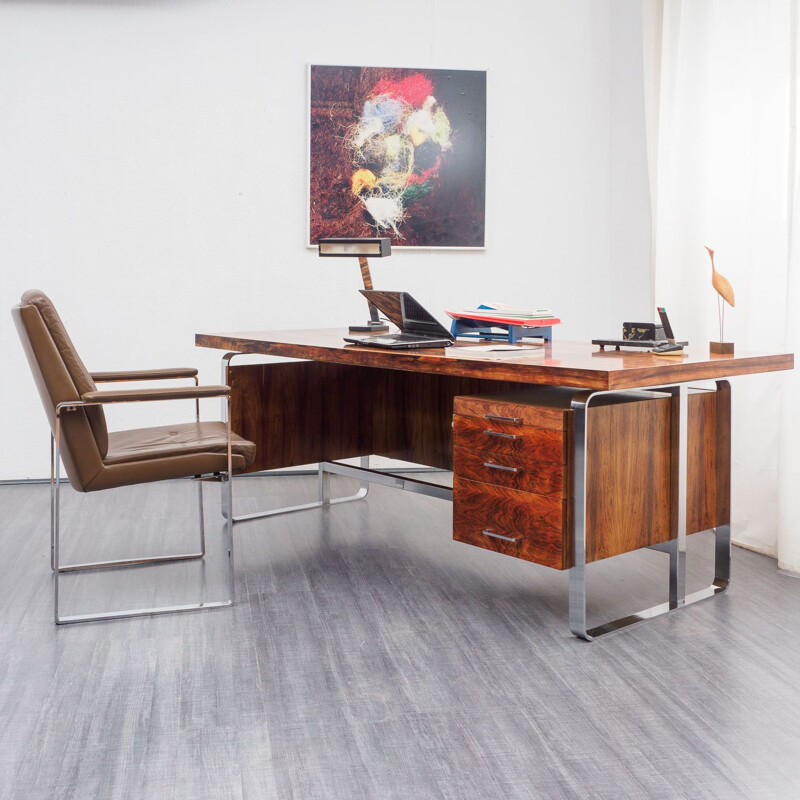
[453,388,730,569]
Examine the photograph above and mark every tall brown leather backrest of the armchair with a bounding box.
[11,291,108,491]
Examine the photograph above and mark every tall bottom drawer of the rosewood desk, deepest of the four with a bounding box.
[453,477,569,569]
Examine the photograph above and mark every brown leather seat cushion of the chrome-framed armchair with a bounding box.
[103,421,256,466]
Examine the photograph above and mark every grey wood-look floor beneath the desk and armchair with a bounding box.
[0,477,800,800]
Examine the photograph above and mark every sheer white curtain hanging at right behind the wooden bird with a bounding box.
[643,0,800,573]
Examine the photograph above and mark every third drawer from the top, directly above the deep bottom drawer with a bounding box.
[453,447,564,495]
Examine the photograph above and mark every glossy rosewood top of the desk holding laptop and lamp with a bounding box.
[195,328,794,390]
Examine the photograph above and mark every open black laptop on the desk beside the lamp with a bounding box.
[344,289,455,350]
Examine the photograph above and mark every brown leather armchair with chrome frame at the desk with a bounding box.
[11,290,255,625]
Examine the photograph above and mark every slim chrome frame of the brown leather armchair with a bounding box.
[50,394,234,625]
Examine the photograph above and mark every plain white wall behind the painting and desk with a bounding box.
[0,0,652,479]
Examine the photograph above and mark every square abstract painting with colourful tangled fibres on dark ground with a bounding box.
[307,65,486,248]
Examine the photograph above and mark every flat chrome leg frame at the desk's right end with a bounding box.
[569,380,731,641]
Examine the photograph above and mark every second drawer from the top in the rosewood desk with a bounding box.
[453,415,566,464]
